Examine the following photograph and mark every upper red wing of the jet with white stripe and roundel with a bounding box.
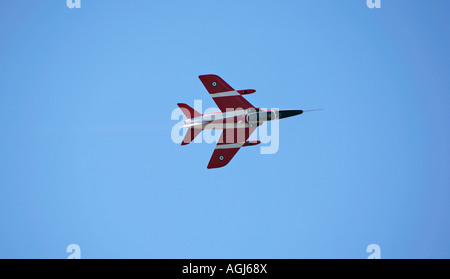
[198,75,253,112]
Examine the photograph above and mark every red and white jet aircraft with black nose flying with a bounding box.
[178,75,303,169]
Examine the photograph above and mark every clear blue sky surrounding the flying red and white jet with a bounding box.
[0,0,450,258]
